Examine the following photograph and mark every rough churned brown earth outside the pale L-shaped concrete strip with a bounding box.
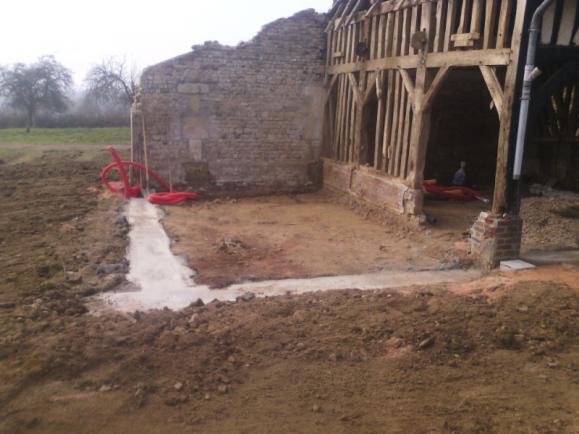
[0,150,579,434]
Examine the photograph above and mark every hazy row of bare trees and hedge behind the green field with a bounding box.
[0,56,139,131]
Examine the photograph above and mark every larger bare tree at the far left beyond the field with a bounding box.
[0,56,72,132]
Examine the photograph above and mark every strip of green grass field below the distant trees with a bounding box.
[0,127,131,145]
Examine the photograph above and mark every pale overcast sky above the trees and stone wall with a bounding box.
[0,0,332,85]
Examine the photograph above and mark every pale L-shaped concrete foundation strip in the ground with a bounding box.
[100,199,481,312]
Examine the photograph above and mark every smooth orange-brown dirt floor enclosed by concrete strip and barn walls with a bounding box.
[163,192,474,288]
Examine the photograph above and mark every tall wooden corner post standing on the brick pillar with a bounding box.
[492,0,527,215]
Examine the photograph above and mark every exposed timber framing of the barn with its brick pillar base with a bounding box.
[323,0,579,265]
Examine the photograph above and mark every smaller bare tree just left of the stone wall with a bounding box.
[85,58,139,105]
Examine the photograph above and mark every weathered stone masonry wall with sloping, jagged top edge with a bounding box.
[133,10,326,195]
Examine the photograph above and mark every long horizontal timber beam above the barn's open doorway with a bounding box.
[327,48,511,75]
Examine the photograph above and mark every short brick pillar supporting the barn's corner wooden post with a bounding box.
[470,212,523,268]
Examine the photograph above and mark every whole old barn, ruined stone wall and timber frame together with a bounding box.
[132,0,579,266]
